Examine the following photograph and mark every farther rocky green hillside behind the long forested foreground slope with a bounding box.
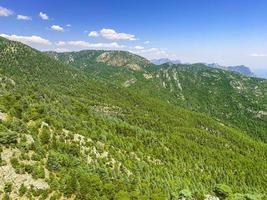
[50,51,267,142]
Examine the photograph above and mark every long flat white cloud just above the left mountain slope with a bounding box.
[0,34,51,45]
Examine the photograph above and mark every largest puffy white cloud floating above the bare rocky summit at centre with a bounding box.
[88,28,136,41]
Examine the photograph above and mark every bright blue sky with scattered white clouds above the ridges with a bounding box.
[0,0,267,77]
